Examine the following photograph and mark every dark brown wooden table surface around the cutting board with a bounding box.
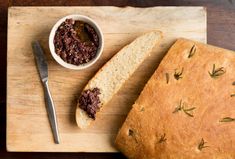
[0,0,235,159]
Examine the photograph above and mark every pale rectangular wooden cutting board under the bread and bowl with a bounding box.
[7,7,206,152]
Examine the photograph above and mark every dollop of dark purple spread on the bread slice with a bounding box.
[78,88,100,119]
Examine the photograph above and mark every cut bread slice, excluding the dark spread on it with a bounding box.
[76,31,162,129]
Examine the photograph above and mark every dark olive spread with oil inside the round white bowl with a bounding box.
[54,19,99,65]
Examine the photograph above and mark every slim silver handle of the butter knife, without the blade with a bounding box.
[43,80,60,144]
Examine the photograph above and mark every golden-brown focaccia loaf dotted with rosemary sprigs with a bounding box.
[115,39,235,159]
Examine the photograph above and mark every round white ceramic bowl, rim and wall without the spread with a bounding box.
[49,14,104,70]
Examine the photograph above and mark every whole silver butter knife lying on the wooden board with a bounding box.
[32,41,60,144]
